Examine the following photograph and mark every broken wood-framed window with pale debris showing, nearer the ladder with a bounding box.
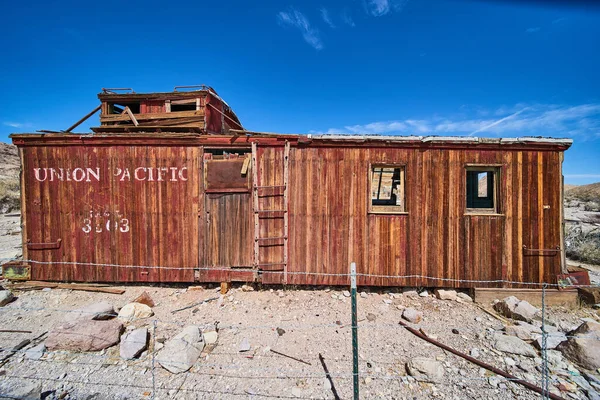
[370,166,406,214]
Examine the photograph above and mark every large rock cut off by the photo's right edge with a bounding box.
[557,321,600,370]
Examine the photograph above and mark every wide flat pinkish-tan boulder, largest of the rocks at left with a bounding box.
[46,319,123,351]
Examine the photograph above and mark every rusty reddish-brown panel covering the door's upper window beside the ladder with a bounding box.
[204,157,250,193]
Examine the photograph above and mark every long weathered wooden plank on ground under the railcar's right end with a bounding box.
[475,288,578,307]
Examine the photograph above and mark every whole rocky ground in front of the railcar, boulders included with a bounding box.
[0,286,600,399]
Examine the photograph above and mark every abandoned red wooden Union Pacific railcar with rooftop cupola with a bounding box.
[12,88,571,287]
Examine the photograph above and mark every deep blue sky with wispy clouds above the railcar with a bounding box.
[0,0,600,184]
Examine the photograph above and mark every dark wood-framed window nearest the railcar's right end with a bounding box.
[467,167,498,212]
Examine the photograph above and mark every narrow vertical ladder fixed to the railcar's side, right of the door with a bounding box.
[252,141,290,284]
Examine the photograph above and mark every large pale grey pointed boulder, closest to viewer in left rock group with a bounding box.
[156,325,204,374]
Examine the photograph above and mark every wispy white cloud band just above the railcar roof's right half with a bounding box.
[312,103,600,140]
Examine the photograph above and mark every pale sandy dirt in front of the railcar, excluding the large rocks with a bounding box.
[0,286,597,399]
